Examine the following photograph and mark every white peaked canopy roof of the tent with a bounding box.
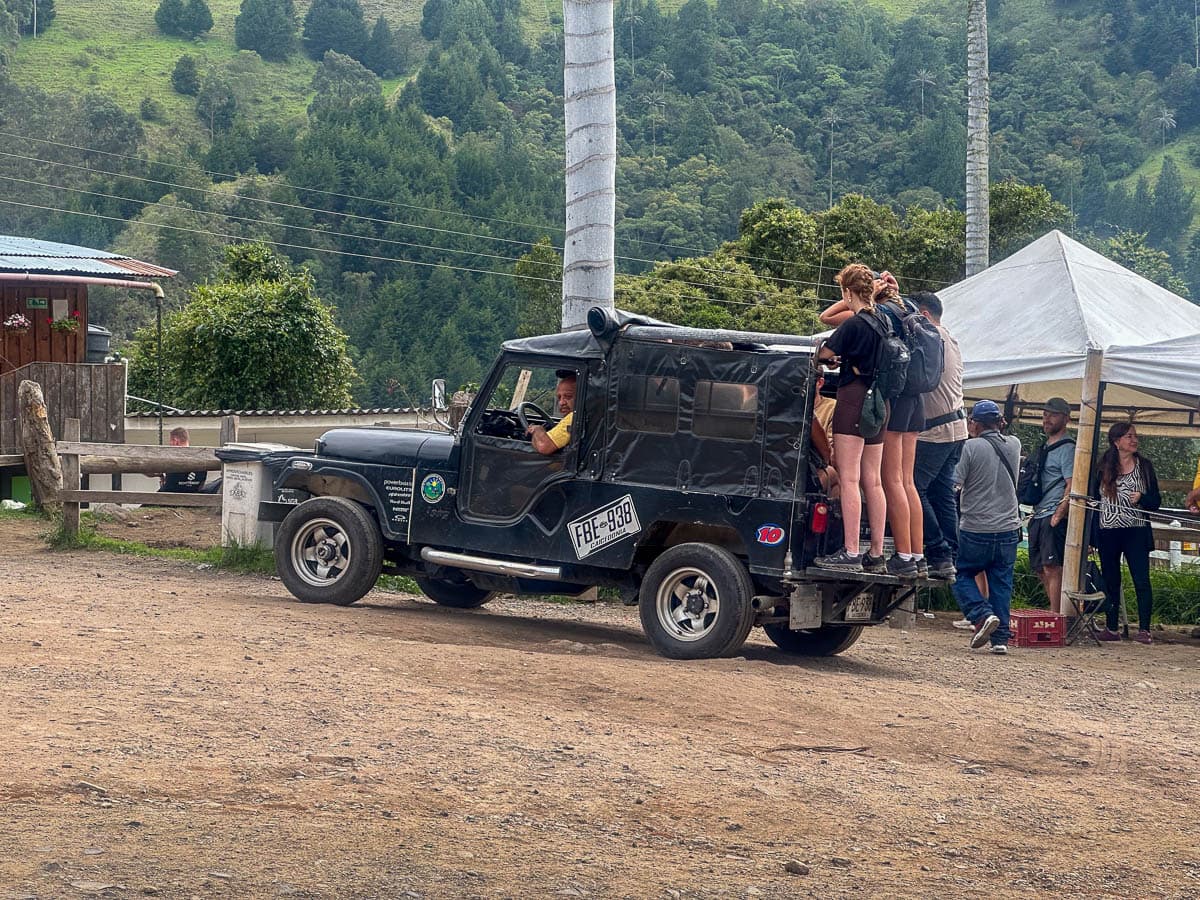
[938,232,1200,434]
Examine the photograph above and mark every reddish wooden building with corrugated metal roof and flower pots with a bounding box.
[0,235,175,456]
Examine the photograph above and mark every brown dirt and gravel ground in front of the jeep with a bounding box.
[0,518,1200,898]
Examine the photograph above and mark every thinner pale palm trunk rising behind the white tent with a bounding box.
[966,0,989,277]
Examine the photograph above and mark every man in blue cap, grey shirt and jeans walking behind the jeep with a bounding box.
[954,400,1021,655]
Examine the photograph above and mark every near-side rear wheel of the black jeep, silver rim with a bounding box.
[638,544,754,659]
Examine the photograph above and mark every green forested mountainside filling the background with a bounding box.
[0,0,1200,404]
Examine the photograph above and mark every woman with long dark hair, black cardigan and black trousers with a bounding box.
[1088,422,1162,643]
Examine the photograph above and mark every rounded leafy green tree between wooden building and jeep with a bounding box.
[130,244,355,409]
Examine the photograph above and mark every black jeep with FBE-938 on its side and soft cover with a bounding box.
[266,308,916,659]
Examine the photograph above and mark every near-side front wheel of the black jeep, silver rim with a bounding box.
[275,497,383,606]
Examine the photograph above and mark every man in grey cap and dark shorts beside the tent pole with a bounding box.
[1025,397,1075,612]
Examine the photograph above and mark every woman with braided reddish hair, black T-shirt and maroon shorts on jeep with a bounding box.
[815,263,887,572]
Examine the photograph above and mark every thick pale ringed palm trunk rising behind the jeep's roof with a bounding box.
[563,0,617,330]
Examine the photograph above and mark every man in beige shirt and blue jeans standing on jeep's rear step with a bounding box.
[912,290,967,581]
